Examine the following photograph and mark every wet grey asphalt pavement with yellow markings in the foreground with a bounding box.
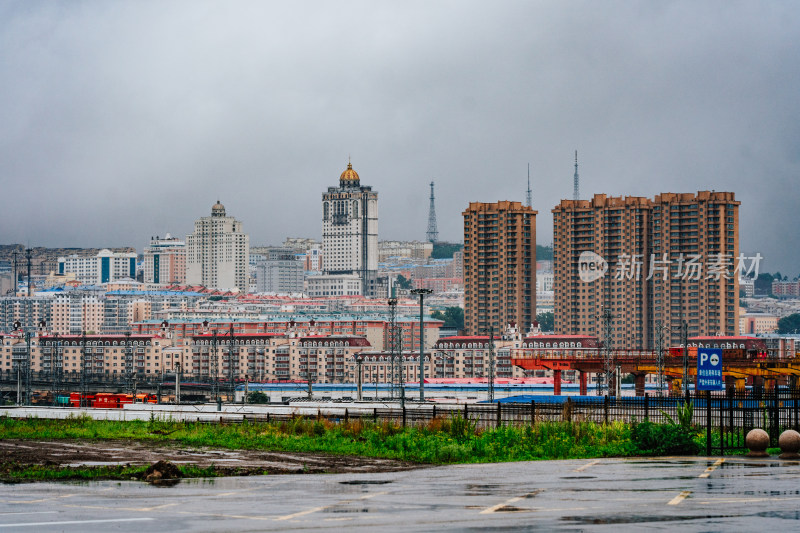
[0,458,800,533]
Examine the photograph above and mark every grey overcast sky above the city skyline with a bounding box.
[0,0,800,270]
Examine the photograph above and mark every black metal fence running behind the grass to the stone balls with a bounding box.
[238,389,800,455]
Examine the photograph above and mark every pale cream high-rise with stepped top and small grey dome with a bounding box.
[186,202,250,292]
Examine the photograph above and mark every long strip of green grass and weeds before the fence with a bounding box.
[0,415,641,464]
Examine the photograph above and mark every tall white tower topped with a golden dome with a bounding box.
[318,162,378,296]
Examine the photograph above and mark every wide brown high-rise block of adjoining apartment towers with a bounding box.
[553,191,739,349]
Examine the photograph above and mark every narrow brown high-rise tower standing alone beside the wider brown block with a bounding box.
[463,202,536,335]
